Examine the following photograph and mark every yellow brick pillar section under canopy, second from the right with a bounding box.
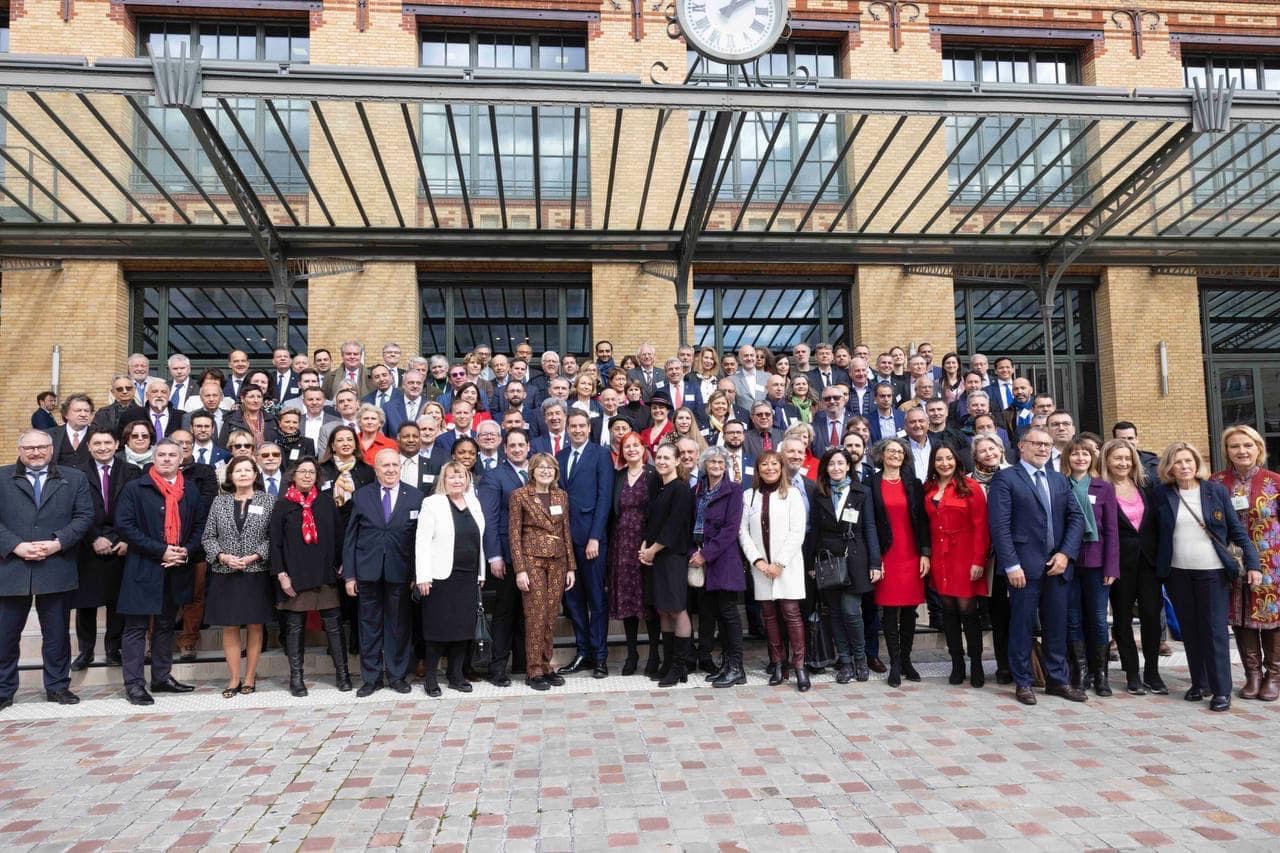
[852,266,956,362]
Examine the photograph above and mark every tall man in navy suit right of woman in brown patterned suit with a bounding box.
[556,409,613,679]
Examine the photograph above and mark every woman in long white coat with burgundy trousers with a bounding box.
[737,451,809,693]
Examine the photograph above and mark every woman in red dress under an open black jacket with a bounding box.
[868,438,929,686]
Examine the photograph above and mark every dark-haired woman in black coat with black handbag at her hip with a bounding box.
[809,447,883,684]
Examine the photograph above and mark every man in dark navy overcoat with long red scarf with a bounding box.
[115,438,209,704]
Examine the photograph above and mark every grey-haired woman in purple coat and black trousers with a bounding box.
[689,447,746,686]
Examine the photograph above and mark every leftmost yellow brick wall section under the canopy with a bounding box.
[0,261,129,438]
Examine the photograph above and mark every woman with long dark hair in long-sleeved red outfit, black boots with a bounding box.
[924,443,991,688]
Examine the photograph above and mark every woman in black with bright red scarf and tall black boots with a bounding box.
[270,459,351,695]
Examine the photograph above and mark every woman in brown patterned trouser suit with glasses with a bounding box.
[509,453,576,690]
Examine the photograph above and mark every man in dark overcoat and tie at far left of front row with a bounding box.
[0,429,93,710]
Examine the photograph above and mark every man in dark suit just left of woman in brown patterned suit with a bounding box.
[476,429,529,686]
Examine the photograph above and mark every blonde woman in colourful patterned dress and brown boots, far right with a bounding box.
[1211,424,1280,702]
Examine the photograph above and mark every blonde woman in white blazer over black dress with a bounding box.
[415,462,484,698]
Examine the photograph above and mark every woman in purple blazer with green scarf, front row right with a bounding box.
[1062,437,1120,695]
